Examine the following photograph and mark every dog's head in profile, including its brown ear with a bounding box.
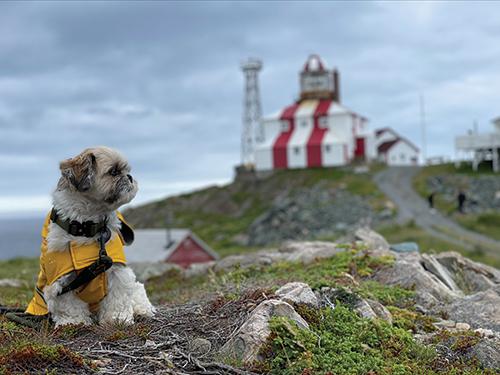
[58,147,138,210]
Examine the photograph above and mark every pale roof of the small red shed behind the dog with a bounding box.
[125,229,219,262]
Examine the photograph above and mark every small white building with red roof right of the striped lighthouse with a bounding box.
[375,128,419,166]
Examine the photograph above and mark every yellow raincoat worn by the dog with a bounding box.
[26,212,131,315]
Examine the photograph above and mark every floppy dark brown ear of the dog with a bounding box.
[59,151,96,191]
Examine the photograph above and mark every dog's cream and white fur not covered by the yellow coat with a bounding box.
[44,147,155,327]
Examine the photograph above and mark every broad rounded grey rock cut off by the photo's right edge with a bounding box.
[446,285,500,332]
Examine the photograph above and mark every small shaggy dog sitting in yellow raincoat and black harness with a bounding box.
[26,147,155,327]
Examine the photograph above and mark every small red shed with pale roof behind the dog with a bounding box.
[125,229,219,268]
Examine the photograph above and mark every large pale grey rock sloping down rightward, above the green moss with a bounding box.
[373,253,462,309]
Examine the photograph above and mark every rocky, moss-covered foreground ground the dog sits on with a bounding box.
[0,229,500,375]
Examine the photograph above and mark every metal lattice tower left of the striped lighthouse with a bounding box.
[241,59,264,165]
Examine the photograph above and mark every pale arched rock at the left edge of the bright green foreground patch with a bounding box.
[221,300,309,363]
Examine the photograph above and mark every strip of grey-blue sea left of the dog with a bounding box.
[0,217,44,259]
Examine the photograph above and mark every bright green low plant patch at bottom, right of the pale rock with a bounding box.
[260,304,435,375]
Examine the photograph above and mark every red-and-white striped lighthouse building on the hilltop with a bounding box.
[255,55,376,170]
